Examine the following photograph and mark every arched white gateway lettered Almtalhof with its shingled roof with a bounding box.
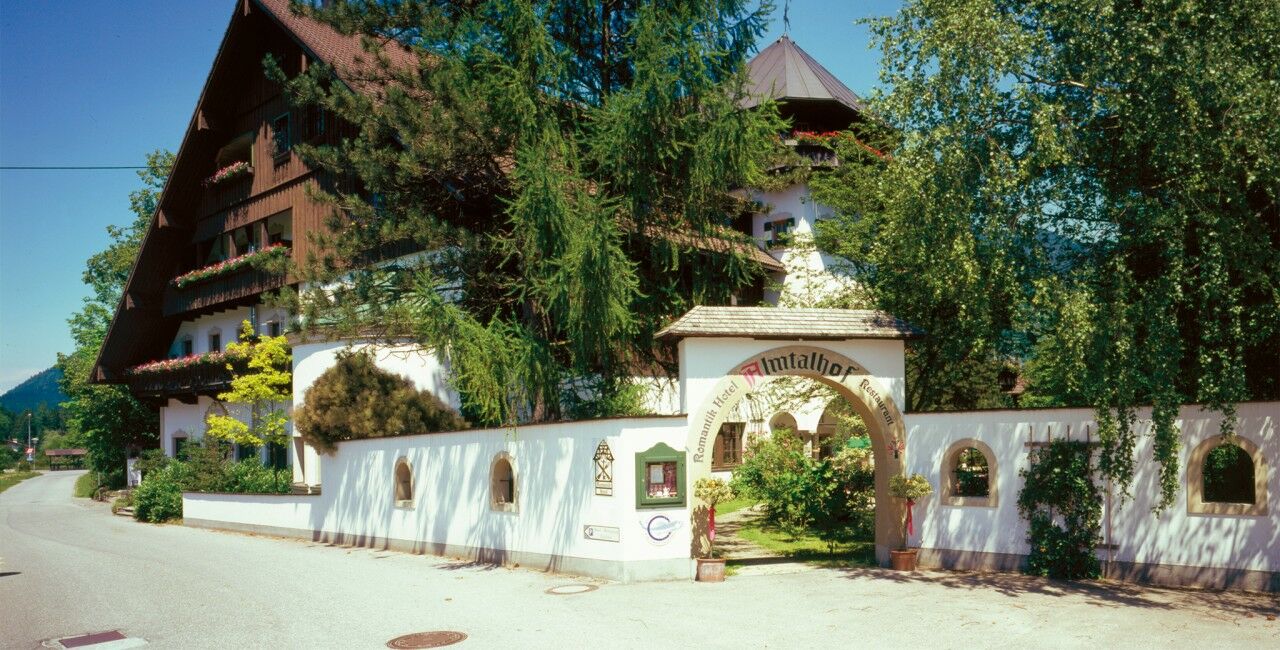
[659,307,919,564]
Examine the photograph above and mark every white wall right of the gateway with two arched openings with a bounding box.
[906,402,1280,572]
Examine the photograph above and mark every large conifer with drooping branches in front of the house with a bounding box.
[274,0,781,424]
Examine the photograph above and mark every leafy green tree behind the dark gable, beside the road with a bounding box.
[58,151,173,485]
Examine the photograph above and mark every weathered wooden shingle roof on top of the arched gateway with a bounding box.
[657,306,924,340]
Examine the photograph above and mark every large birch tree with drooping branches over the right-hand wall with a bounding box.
[820,0,1280,508]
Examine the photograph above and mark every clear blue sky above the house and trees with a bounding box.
[0,0,899,392]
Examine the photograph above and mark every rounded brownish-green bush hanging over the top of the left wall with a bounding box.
[293,351,467,453]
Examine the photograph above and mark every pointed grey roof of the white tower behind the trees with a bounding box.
[748,35,867,113]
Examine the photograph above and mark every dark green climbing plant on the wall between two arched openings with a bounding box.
[1018,440,1102,580]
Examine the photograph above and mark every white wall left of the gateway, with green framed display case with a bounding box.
[184,417,690,578]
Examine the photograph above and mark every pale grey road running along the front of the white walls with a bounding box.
[0,472,1280,649]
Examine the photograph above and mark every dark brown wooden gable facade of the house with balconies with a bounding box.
[93,0,378,386]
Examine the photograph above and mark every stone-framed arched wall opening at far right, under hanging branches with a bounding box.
[1187,435,1267,517]
